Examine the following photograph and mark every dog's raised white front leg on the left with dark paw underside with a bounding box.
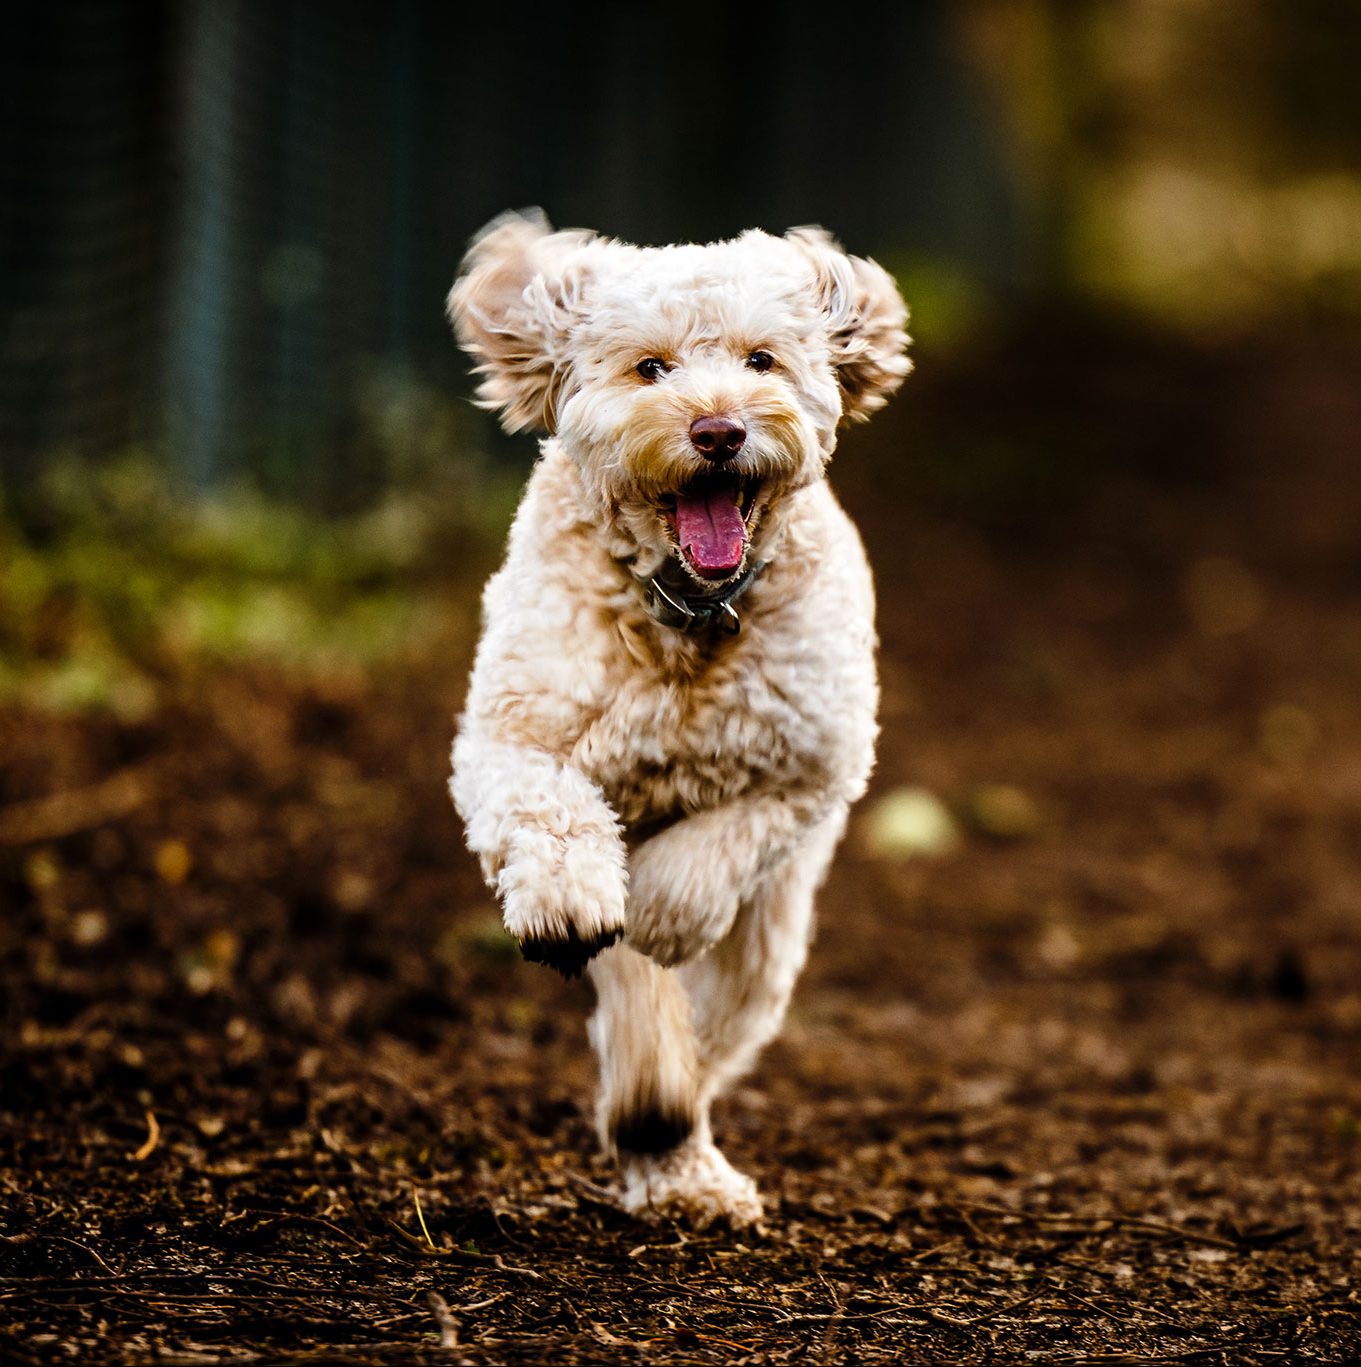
[450,725,627,977]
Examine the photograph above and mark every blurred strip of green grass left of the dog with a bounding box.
[0,454,521,719]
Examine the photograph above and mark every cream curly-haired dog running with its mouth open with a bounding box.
[450,213,910,1225]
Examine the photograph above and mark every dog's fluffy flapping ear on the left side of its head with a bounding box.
[448,209,594,432]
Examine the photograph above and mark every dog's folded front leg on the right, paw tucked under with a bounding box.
[624,791,835,965]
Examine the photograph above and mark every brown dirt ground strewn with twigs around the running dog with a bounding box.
[0,333,1361,1363]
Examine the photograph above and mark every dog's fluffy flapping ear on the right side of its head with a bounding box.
[786,227,911,422]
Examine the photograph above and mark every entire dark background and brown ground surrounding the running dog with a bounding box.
[0,0,1361,1363]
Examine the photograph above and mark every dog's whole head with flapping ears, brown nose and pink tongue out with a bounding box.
[450,216,910,586]
